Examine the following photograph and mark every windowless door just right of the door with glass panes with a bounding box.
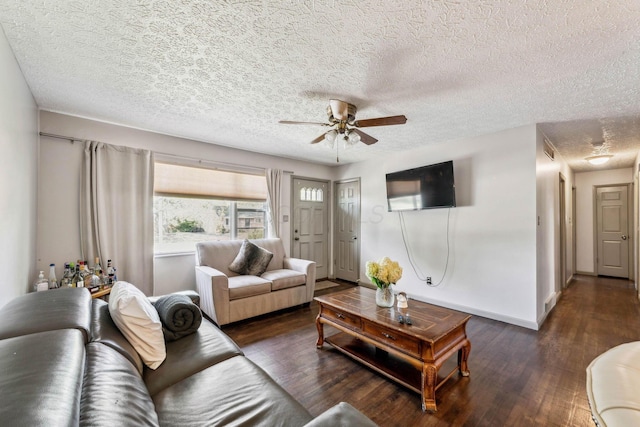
[334,179,360,282]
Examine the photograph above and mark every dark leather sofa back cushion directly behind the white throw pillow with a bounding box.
[91,298,144,374]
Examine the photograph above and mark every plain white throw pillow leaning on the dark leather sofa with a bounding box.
[109,282,167,369]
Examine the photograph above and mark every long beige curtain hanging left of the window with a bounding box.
[80,141,153,295]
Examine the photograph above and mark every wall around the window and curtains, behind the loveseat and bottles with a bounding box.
[37,111,335,295]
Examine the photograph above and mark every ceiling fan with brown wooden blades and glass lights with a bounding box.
[278,99,407,162]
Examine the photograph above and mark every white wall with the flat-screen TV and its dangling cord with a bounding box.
[337,125,538,329]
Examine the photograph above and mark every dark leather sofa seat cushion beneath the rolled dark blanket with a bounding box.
[144,319,243,396]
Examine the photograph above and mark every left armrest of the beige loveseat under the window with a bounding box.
[196,265,229,325]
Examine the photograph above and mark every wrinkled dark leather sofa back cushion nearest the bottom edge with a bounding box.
[82,342,158,427]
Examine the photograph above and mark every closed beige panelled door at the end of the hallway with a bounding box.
[596,185,629,278]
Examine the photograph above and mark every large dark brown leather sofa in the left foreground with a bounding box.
[0,289,375,426]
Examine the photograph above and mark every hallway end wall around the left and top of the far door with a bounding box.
[575,168,633,274]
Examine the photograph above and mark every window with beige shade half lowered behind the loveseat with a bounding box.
[153,162,267,253]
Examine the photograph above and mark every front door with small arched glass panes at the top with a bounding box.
[292,176,329,279]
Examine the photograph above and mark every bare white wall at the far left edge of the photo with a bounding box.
[0,27,38,306]
